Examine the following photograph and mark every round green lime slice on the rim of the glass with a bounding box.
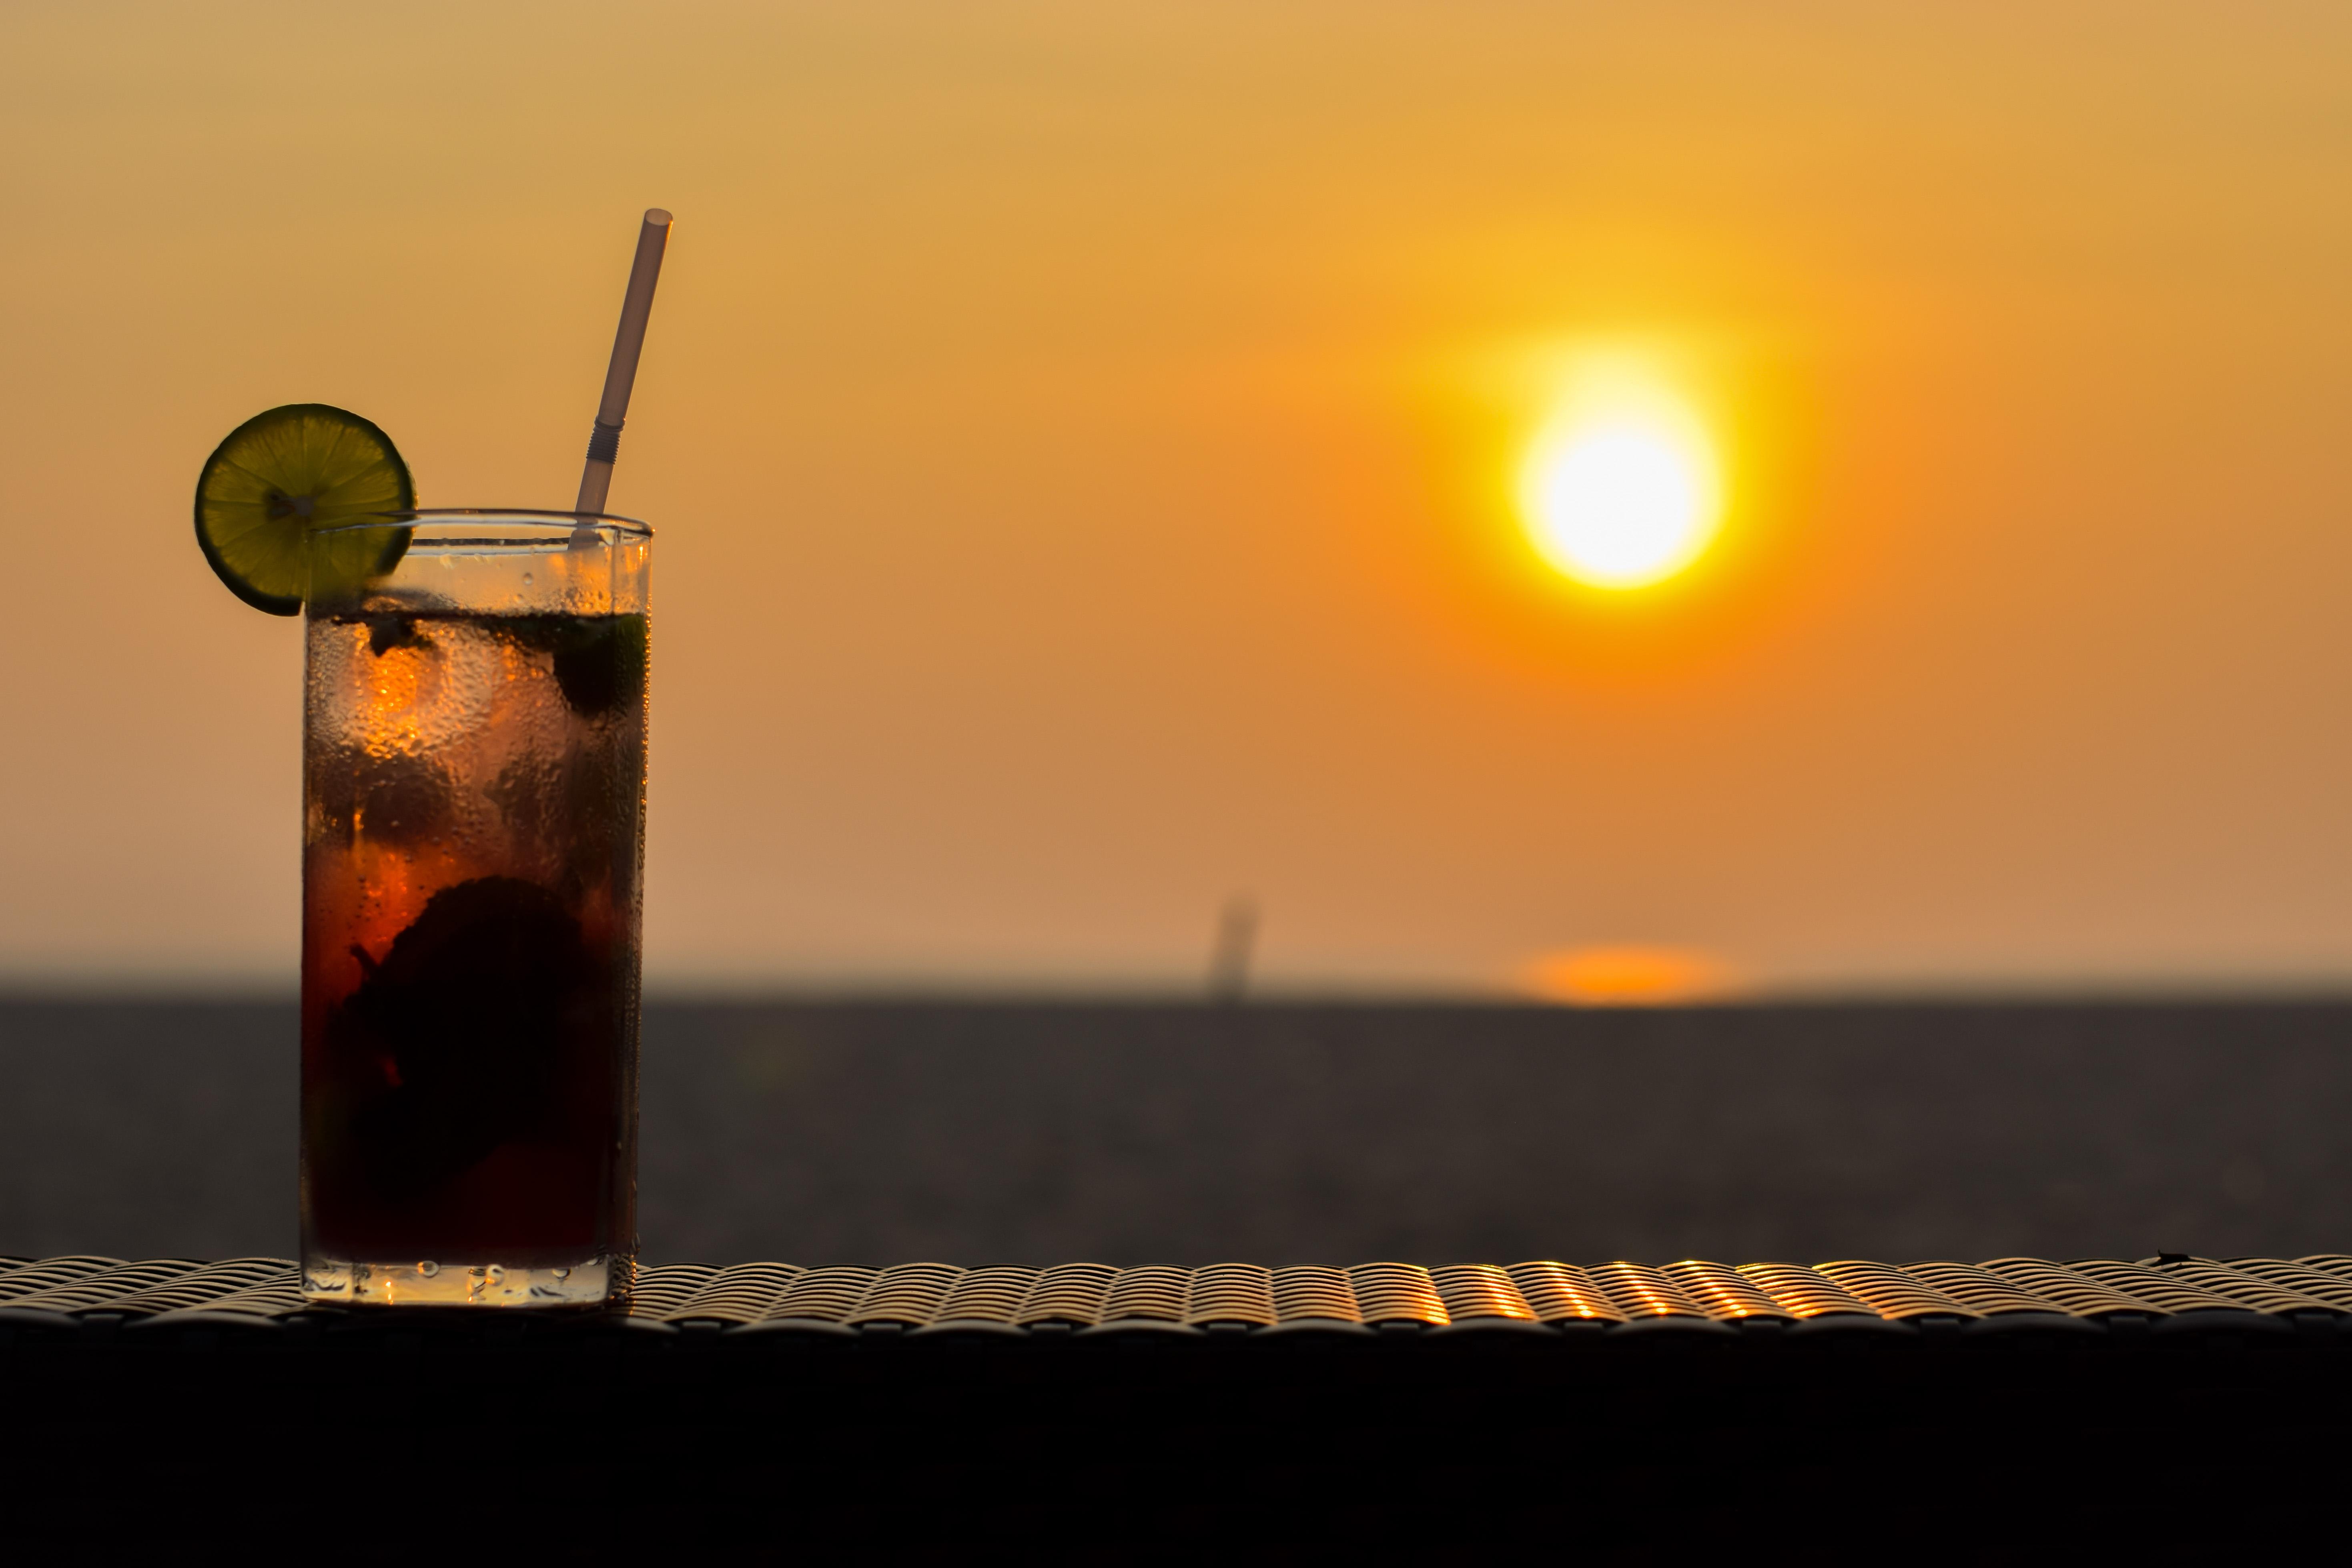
[195,402,416,616]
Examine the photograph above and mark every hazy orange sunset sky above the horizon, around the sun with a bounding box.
[0,0,2352,987]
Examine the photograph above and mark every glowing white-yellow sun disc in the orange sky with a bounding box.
[1520,376,1722,590]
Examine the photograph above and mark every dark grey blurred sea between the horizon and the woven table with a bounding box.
[0,999,2352,1265]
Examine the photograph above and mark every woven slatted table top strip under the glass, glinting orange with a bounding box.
[0,1253,2352,1337]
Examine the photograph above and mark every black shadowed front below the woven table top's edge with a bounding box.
[0,1319,2352,1563]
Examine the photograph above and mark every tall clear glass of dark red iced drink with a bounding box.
[301,510,652,1307]
